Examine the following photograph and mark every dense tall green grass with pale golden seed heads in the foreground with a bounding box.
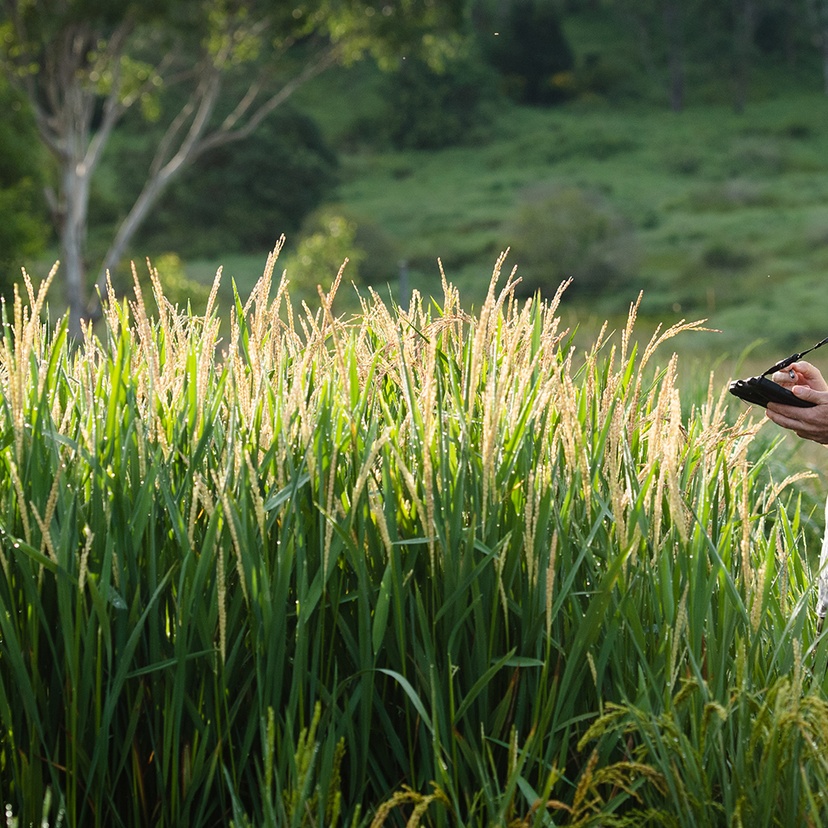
[0,249,828,826]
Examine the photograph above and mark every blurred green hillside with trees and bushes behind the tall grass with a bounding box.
[0,0,828,366]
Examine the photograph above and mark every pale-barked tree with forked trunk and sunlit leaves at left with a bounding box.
[0,0,463,333]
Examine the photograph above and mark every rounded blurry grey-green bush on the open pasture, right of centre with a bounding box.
[507,187,638,296]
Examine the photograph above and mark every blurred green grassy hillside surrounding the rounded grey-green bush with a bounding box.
[340,94,828,339]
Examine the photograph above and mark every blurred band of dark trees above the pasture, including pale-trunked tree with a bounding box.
[0,0,828,320]
